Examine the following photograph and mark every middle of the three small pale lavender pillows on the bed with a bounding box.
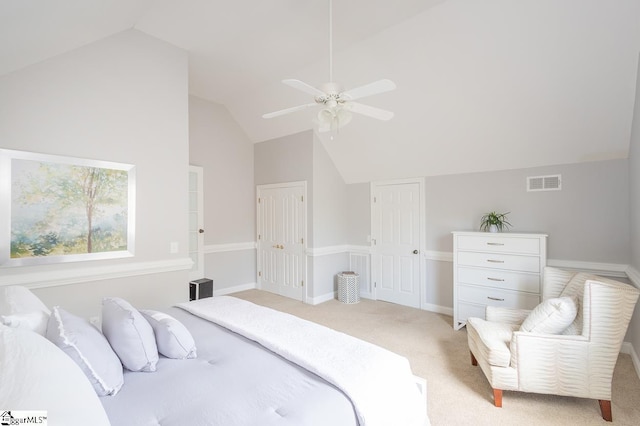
[102,297,158,371]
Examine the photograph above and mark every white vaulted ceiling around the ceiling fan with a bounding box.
[0,0,640,183]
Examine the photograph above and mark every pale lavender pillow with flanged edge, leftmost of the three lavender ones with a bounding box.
[47,306,124,396]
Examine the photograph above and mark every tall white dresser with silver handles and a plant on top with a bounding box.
[453,232,547,330]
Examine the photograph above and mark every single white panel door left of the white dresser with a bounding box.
[371,182,424,308]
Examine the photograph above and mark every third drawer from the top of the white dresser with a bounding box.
[457,267,540,294]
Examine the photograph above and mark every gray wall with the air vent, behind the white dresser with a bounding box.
[347,160,630,308]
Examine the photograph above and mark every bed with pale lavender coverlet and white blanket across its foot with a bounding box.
[0,286,429,426]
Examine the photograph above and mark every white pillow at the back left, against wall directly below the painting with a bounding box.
[0,286,51,336]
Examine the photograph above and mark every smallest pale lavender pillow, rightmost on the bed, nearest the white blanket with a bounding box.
[140,310,197,359]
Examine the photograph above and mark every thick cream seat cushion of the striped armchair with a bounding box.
[467,317,520,367]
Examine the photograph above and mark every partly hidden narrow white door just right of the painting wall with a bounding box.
[188,166,204,280]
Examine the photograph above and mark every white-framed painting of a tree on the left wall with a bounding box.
[0,149,136,266]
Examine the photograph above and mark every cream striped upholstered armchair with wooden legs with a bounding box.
[467,267,640,421]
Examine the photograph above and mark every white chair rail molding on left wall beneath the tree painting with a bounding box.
[0,257,193,288]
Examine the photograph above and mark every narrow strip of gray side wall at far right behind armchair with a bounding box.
[627,52,640,355]
